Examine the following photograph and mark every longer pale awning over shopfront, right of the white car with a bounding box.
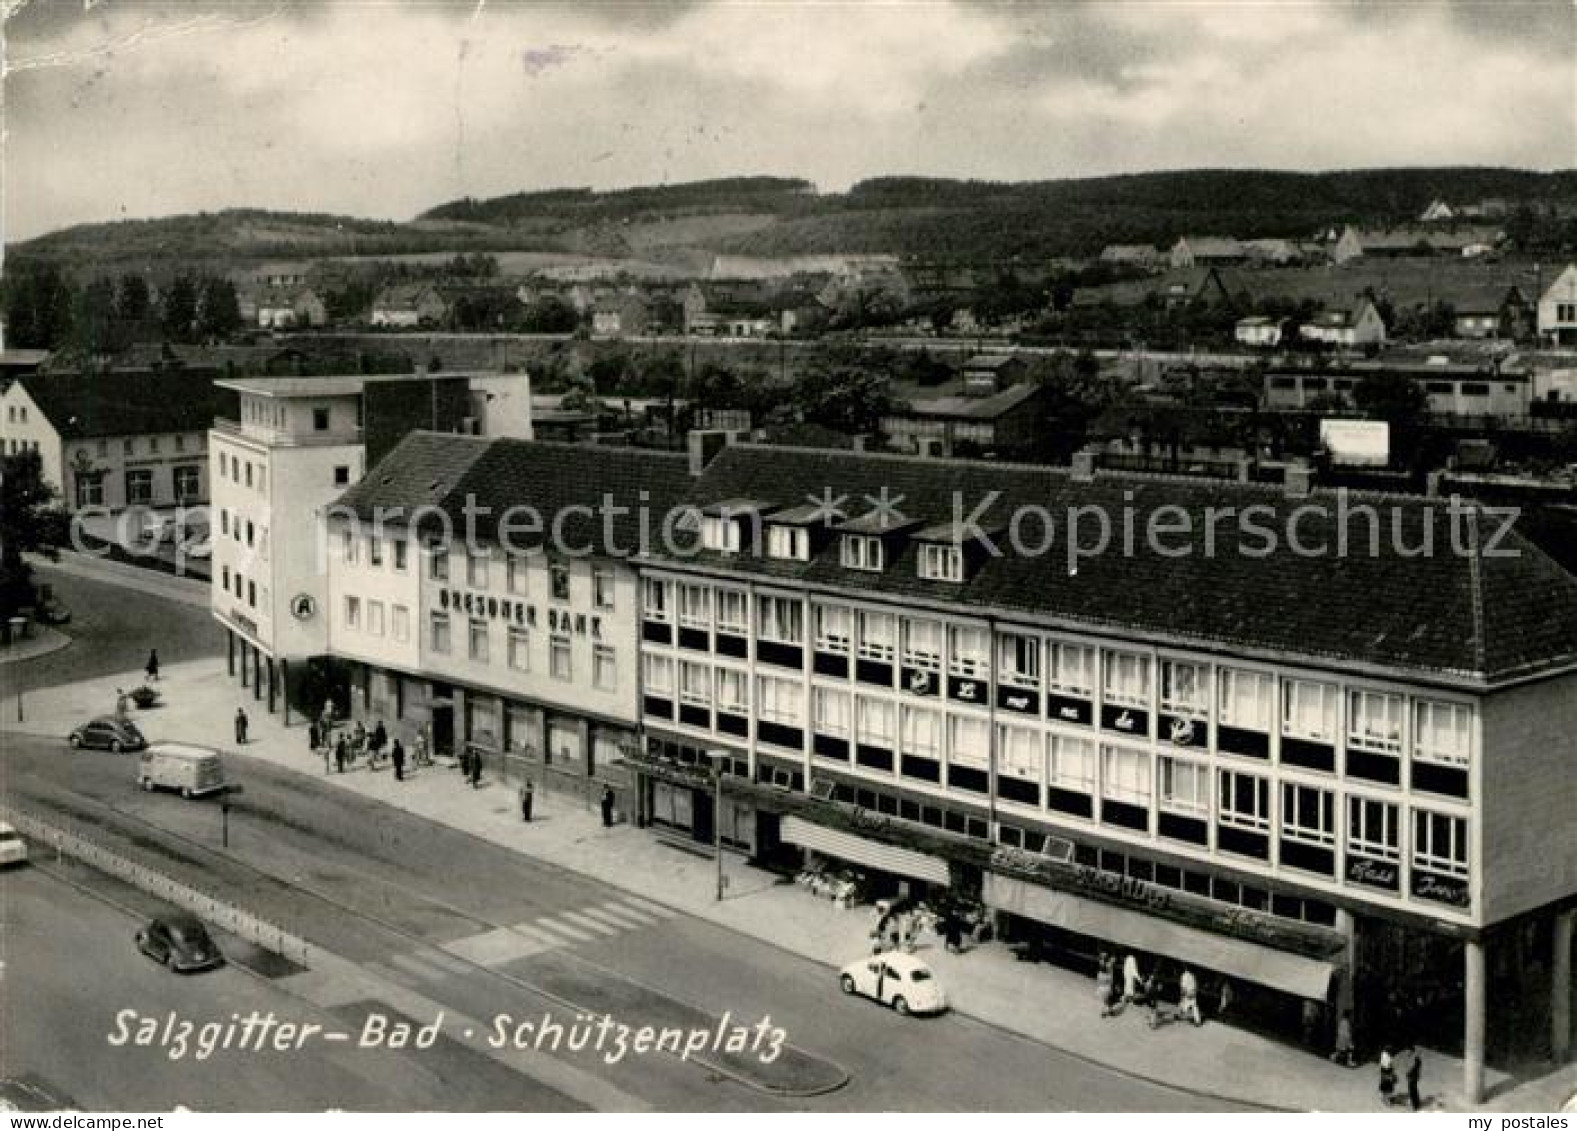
[986,872,1334,1002]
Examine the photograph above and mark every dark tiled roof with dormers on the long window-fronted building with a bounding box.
[674,445,1577,681]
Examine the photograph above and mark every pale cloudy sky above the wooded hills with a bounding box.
[0,0,1577,241]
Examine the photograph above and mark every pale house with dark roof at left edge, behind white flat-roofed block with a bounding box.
[0,369,235,511]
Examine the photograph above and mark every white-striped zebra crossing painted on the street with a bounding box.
[378,896,678,984]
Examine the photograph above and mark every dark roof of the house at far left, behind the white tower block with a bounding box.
[17,369,238,440]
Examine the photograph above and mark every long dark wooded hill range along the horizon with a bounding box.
[11,169,1577,265]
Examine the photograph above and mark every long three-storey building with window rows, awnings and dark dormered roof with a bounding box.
[636,435,1577,1092]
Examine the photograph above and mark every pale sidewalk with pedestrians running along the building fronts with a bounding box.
[0,659,1577,1112]
